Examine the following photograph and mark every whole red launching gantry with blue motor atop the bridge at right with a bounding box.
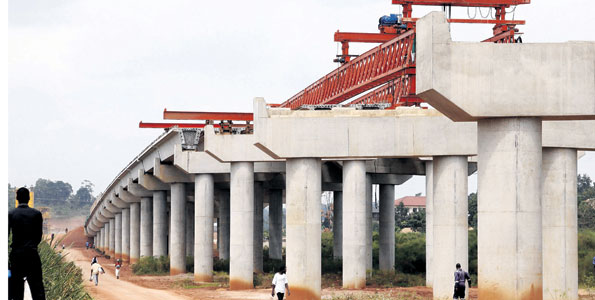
[279,0,531,109]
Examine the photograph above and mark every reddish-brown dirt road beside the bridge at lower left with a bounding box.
[67,248,192,300]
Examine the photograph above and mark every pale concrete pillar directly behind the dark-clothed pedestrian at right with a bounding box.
[432,156,470,299]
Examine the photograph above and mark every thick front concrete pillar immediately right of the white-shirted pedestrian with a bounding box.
[286,158,322,300]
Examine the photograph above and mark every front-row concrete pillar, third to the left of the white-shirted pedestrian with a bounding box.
[169,183,186,275]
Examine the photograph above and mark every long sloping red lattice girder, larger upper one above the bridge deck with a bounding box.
[280,30,415,109]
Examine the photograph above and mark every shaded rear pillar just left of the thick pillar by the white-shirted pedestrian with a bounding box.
[269,190,283,260]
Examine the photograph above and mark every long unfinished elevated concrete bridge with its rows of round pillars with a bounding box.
[85,13,595,299]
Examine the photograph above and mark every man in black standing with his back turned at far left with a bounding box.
[8,188,45,300]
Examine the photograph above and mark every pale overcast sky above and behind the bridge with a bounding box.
[8,0,595,196]
